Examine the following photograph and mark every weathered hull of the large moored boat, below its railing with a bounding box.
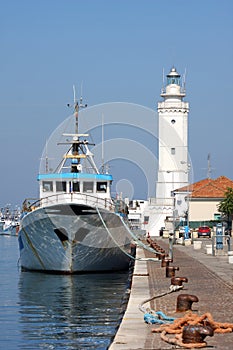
[19,203,131,273]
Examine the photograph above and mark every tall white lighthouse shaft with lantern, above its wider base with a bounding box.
[156,67,189,200]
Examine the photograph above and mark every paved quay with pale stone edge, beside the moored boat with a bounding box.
[109,237,233,350]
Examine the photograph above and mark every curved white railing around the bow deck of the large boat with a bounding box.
[24,192,117,211]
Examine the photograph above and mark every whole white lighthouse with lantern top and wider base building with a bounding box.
[144,67,190,236]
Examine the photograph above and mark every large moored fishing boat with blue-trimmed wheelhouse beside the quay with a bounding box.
[18,95,132,274]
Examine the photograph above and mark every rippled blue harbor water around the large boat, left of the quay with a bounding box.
[0,236,129,350]
